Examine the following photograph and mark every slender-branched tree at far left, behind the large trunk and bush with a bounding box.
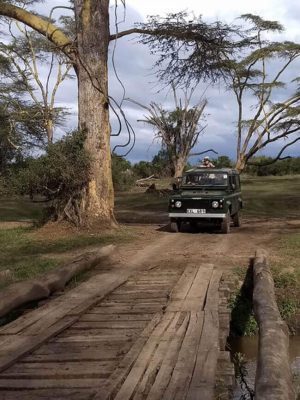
[0,22,72,143]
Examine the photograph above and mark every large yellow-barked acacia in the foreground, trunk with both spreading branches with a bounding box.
[0,0,240,226]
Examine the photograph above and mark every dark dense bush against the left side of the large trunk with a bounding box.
[11,132,90,219]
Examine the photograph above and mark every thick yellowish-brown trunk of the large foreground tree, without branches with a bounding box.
[75,0,115,227]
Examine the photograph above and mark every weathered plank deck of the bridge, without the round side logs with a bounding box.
[0,264,227,400]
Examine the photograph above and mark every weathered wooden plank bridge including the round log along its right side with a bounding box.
[0,248,295,400]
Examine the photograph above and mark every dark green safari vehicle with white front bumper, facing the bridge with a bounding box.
[169,168,243,233]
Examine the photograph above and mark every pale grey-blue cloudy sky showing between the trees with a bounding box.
[18,0,300,162]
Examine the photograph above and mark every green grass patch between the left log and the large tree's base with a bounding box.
[0,228,133,287]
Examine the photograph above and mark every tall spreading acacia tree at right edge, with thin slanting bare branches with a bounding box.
[231,14,300,172]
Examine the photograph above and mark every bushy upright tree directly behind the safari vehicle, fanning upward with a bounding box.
[145,86,207,178]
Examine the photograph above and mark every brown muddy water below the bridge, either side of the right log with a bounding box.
[229,336,300,400]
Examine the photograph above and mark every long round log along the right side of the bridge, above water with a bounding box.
[253,250,296,400]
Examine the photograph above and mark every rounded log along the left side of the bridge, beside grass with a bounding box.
[0,245,114,317]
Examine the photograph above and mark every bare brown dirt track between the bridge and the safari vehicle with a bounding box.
[114,219,300,269]
